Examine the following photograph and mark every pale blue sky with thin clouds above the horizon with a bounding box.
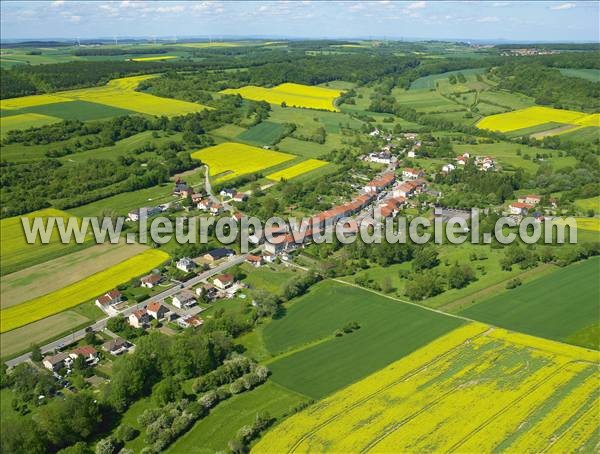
[0,0,600,42]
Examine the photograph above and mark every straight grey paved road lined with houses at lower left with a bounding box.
[6,254,247,367]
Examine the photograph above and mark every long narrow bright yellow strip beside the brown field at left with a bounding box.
[0,249,169,333]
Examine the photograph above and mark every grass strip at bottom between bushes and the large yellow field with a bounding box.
[166,381,306,454]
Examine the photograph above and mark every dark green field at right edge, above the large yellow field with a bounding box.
[461,258,600,349]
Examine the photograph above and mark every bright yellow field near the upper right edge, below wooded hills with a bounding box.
[477,106,600,132]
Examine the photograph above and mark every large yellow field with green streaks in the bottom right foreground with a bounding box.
[253,323,600,453]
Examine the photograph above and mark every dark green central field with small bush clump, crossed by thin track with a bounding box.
[263,281,461,398]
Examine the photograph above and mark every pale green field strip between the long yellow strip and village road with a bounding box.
[0,311,90,358]
